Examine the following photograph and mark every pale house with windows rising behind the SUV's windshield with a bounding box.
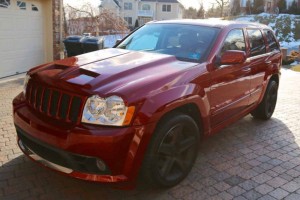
[100,0,184,26]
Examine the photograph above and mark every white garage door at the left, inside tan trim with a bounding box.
[0,0,45,78]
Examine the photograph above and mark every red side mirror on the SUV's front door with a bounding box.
[219,50,246,65]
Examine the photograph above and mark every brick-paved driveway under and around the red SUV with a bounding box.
[0,70,300,200]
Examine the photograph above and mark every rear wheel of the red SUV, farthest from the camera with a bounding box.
[251,80,278,120]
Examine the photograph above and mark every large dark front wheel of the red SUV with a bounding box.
[141,112,200,187]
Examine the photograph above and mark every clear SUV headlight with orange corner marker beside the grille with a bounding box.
[81,95,135,126]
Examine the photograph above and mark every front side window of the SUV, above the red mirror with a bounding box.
[221,29,245,54]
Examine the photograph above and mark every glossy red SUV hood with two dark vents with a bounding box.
[29,49,197,100]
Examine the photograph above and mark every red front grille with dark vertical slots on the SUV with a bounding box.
[26,80,83,123]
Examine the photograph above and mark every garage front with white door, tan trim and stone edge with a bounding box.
[0,0,63,78]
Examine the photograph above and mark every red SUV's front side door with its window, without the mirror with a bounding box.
[210,29,251,127]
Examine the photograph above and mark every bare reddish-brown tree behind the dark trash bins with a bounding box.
[65,2,128,36]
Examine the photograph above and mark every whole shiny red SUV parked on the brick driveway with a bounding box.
[13,20,282,187]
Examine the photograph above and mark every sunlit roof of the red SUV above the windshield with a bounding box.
[149,19,270,29]
